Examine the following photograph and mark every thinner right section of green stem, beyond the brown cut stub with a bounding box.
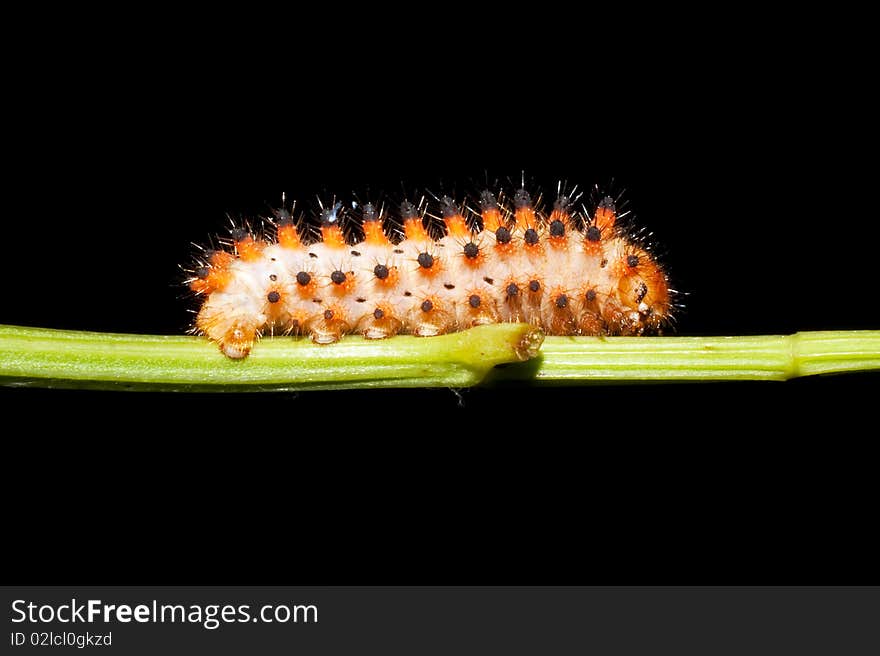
[489,330,880,384]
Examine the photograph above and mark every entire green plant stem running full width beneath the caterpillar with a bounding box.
[0,324,880,392]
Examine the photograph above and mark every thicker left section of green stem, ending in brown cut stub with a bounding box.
[0,324,543,392]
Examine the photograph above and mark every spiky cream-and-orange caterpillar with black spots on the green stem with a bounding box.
[185,183,674,358]
